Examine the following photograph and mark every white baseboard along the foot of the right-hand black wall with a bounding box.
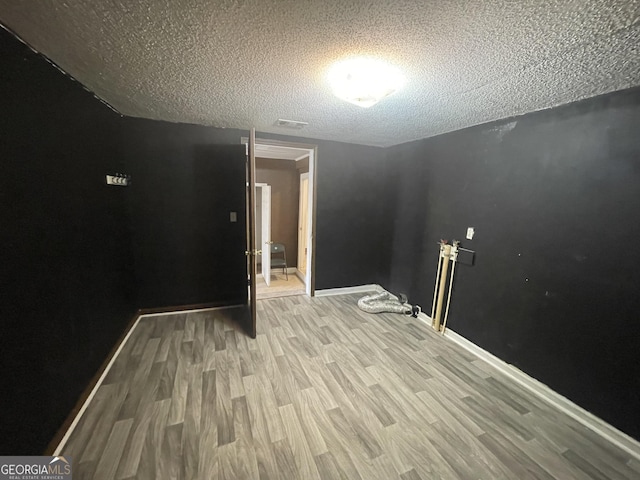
[418,313,640,460]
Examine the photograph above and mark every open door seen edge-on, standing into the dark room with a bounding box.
[245,128,257,338]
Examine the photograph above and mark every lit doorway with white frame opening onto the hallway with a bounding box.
[242,138,317,299]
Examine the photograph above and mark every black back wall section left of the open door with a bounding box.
[122,118,247,308]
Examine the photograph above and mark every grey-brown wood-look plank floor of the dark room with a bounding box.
[63,295,640,480]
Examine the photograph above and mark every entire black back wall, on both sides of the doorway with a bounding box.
[121,124,395,308]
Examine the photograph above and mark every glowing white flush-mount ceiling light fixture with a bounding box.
[329,57,404,108]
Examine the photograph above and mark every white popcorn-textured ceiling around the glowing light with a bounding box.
[0,0,640,146]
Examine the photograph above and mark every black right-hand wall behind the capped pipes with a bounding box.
[388,89,640,438]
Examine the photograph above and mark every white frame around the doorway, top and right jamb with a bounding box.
[240,137,318,296]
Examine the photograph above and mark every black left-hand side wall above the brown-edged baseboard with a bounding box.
[0,29,135,455]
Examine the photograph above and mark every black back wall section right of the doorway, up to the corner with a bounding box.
[258,134,396,289]
